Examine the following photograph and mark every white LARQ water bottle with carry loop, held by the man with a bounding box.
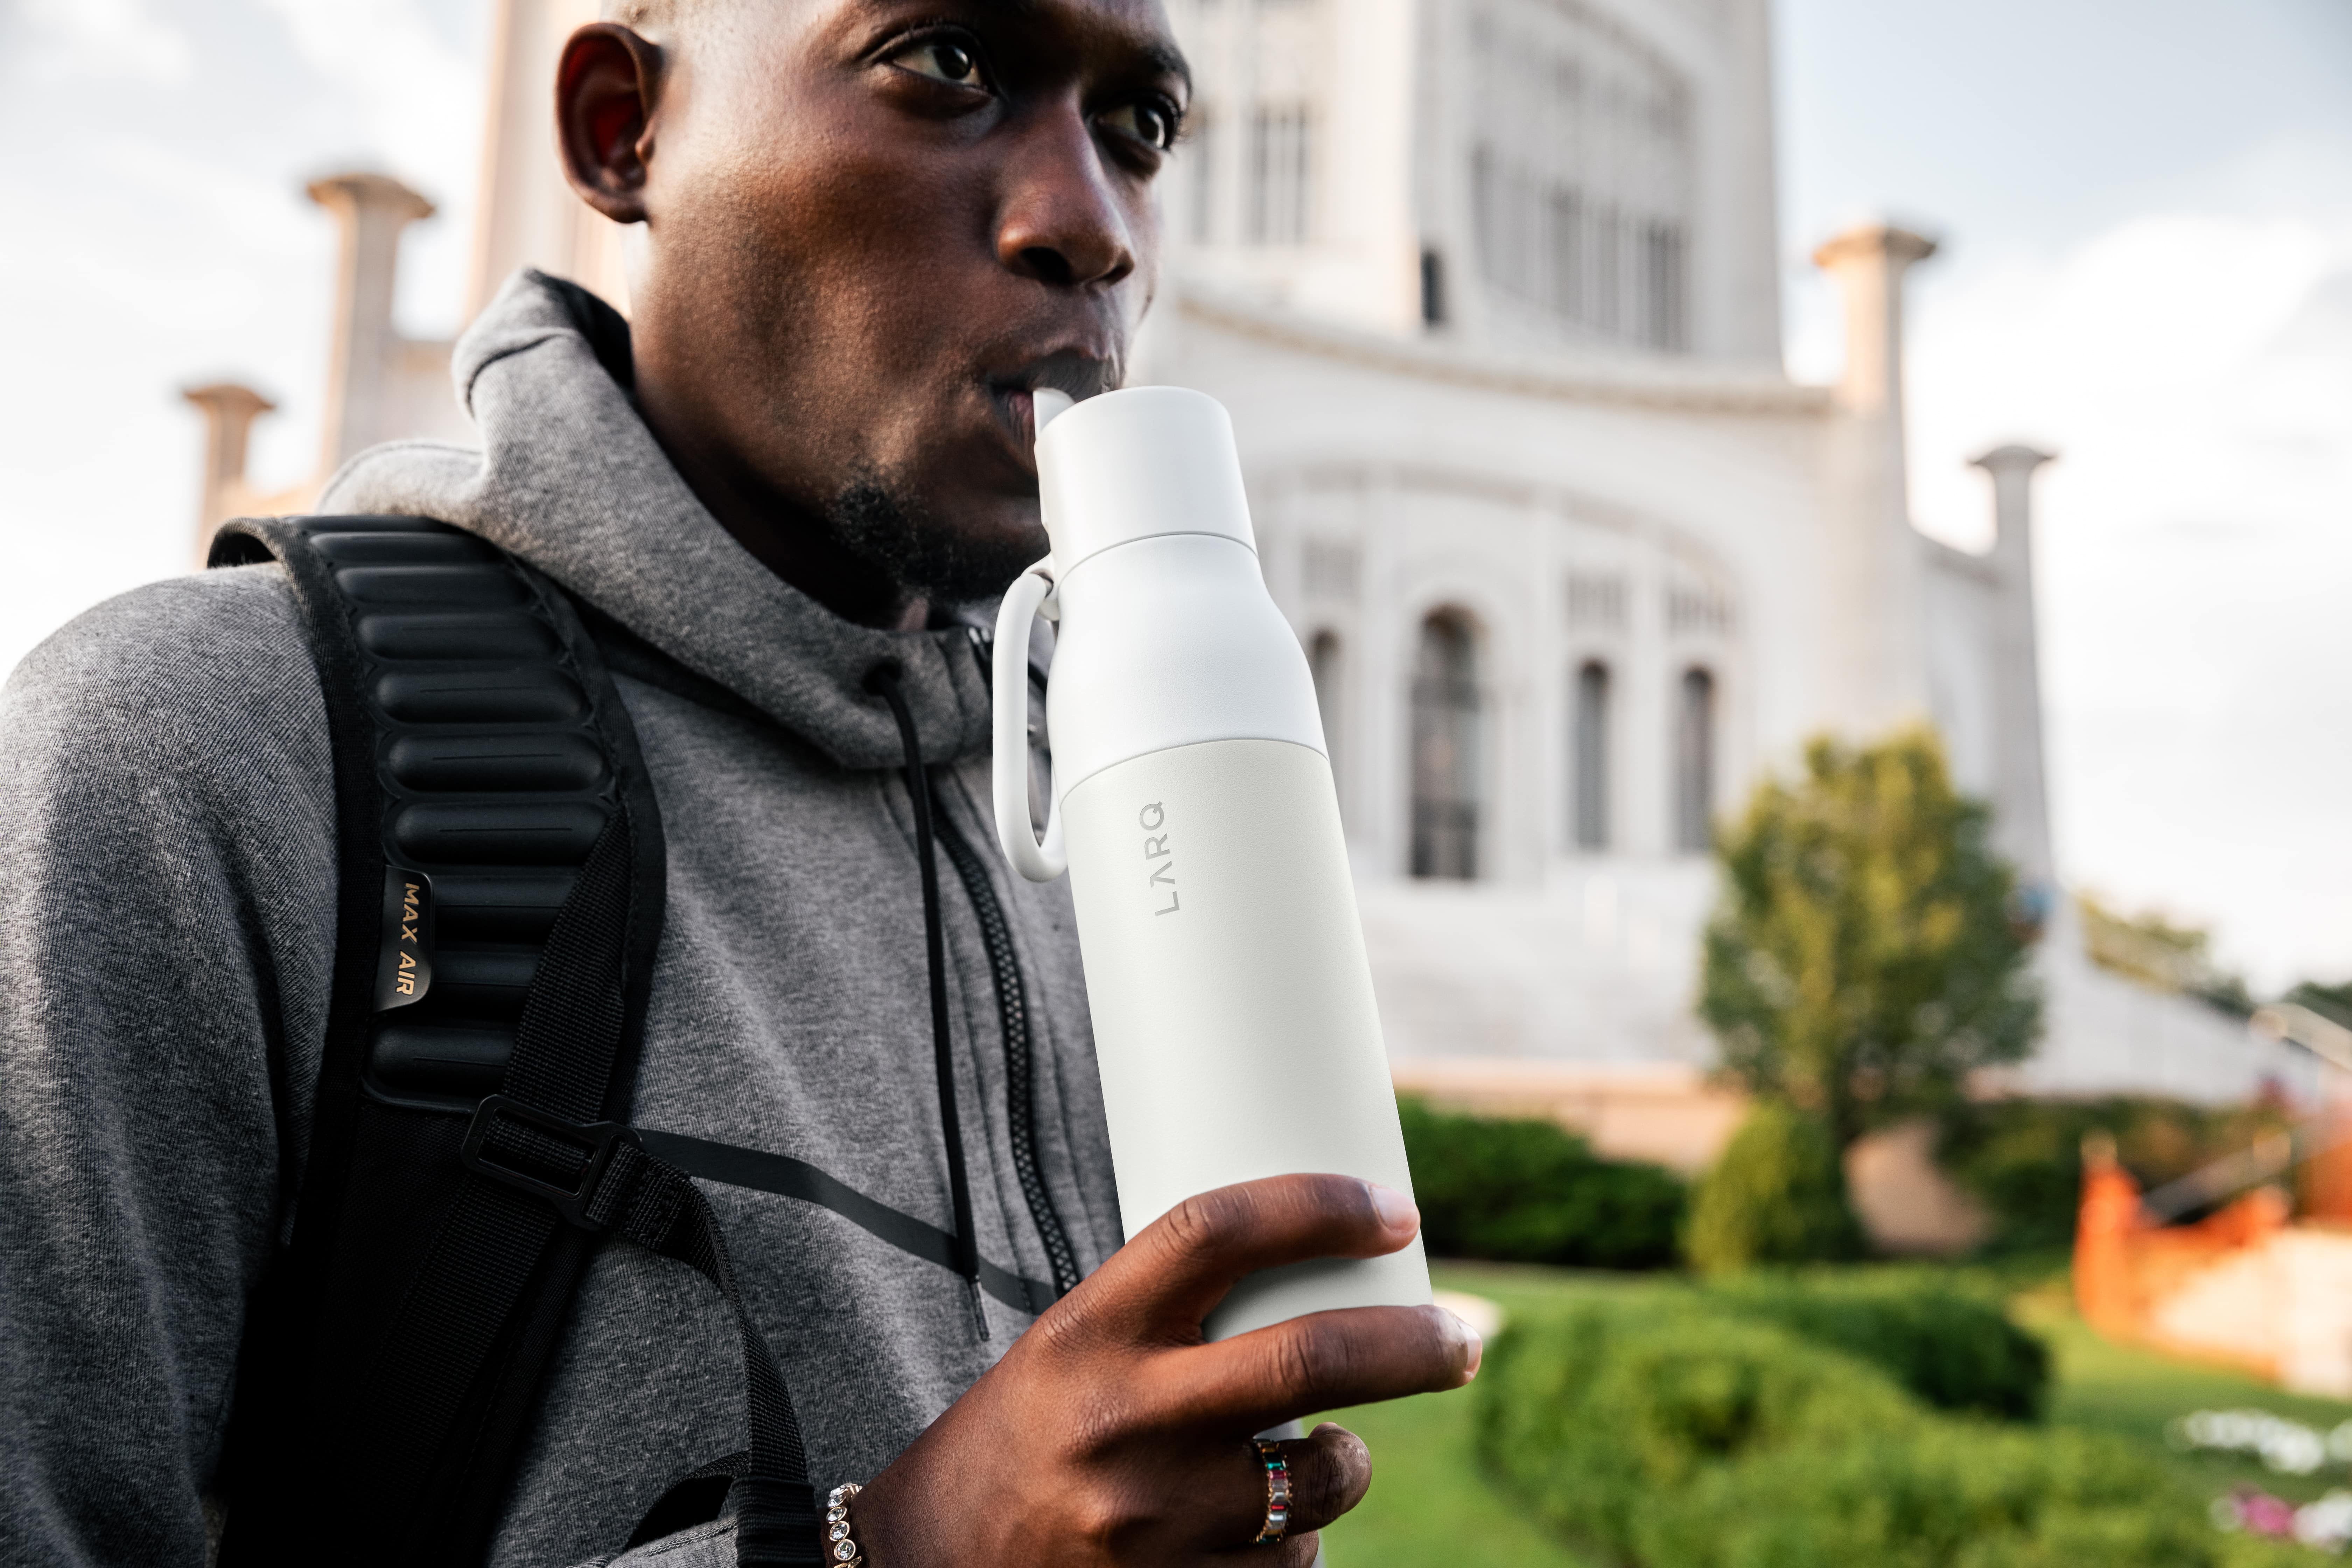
[995,388,1430,1340]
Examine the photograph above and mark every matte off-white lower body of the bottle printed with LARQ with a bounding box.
[1063,741,1430,1338]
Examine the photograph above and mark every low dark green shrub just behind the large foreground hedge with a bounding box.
[1708,1269,2051,1420]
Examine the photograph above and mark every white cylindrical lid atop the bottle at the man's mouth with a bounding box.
[1037,386,1258,574]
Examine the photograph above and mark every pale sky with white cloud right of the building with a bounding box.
[1776,0,2352,987]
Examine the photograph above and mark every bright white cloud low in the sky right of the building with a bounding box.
[1900,200,2352,983]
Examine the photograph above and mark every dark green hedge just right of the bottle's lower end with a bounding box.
[1397,1098,1682,1269]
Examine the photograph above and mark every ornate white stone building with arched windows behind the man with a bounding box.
[193,0,2296,1189]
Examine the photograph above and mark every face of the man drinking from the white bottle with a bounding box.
[565,0,1188,597]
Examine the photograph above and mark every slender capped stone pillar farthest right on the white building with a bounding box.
[1973,444,2058,922]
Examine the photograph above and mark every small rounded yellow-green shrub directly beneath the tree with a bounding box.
[1684,1100,1863,1274]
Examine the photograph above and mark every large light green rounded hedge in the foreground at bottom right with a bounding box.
[1475,1290,2307,1568]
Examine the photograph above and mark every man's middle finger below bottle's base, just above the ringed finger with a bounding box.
[1153,1307,1484,1432]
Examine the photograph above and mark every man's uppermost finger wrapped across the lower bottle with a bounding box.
[1087,1175,1421,1338]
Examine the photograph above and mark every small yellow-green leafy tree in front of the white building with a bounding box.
[1698,729,2042,1149]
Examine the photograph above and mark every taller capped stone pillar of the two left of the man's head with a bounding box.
[310,174,433,472]
